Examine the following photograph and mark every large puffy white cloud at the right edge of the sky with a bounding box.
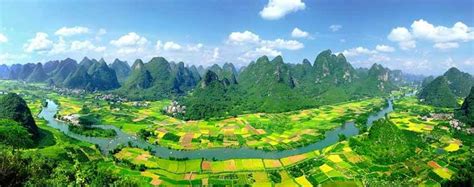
[388,19,474,50]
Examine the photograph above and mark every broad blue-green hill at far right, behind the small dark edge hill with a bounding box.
[418,67,474,108]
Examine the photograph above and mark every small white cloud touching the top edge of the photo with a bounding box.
[260,0,306,20]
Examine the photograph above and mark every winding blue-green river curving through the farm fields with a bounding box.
[39,100,393,160]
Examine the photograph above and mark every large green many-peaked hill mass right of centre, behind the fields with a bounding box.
[181,50,398,119]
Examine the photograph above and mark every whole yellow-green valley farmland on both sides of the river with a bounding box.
[0,81,473,186]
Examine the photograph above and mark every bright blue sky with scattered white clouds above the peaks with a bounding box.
[0,0,474,75]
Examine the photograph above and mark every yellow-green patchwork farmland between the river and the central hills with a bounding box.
[12,81,386,150]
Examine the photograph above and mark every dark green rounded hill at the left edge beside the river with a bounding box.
[0,93,39,138]
